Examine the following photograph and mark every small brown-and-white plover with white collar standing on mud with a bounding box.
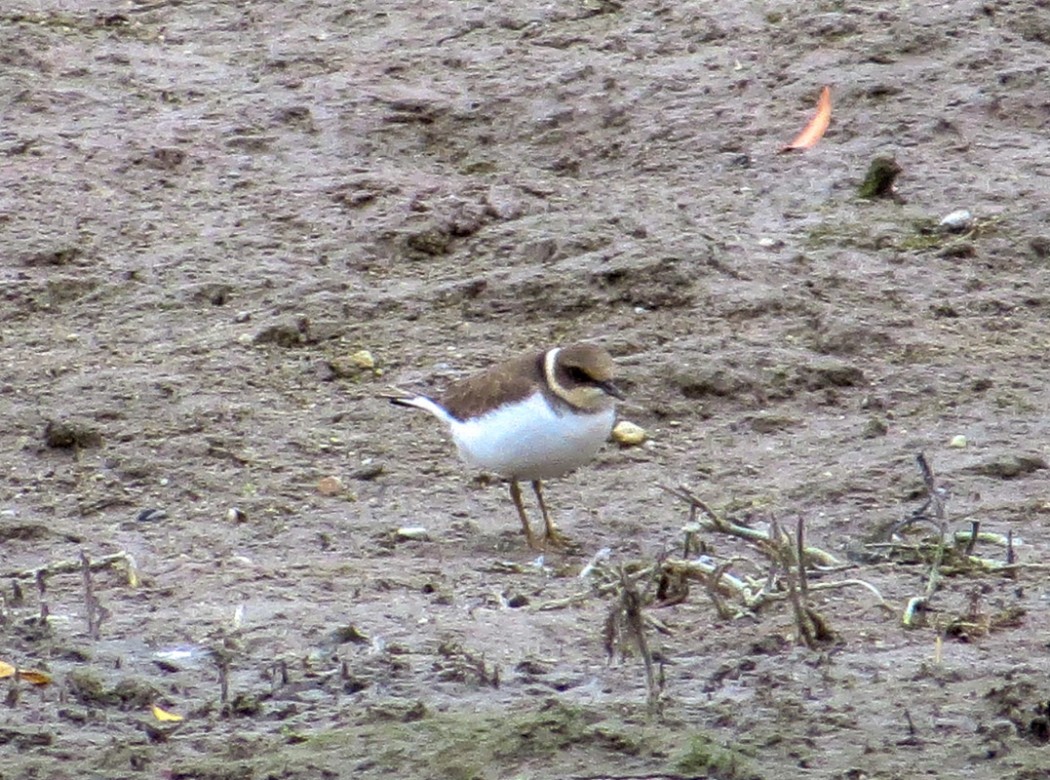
[390,343,624,549]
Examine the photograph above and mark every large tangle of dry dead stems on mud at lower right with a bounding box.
[532,454,1037,712]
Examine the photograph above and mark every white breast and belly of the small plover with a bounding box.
[452,393,615,480]
